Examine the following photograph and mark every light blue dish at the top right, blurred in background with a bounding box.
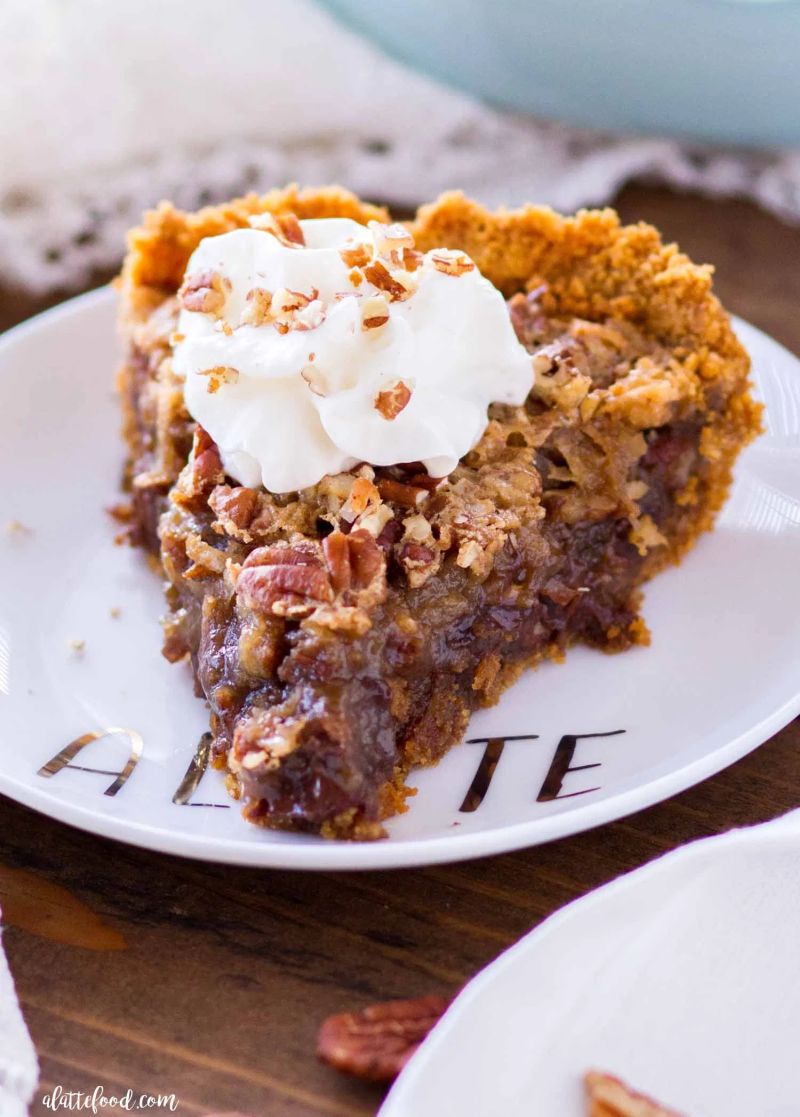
[324,0,800,146]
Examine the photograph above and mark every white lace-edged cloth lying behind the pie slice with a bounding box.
[0,0,800,292]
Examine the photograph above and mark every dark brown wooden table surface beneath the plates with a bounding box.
[0,187,800,1117]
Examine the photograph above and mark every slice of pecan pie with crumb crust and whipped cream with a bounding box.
[120,188,760,838]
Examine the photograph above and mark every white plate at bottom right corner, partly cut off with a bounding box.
[380,811,800,1117]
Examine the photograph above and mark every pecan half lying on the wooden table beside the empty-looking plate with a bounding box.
[316,996,449,1082]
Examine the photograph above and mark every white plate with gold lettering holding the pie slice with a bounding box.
[0,290,800,869]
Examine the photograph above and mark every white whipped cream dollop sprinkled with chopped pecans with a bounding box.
[173,214,533,493]
